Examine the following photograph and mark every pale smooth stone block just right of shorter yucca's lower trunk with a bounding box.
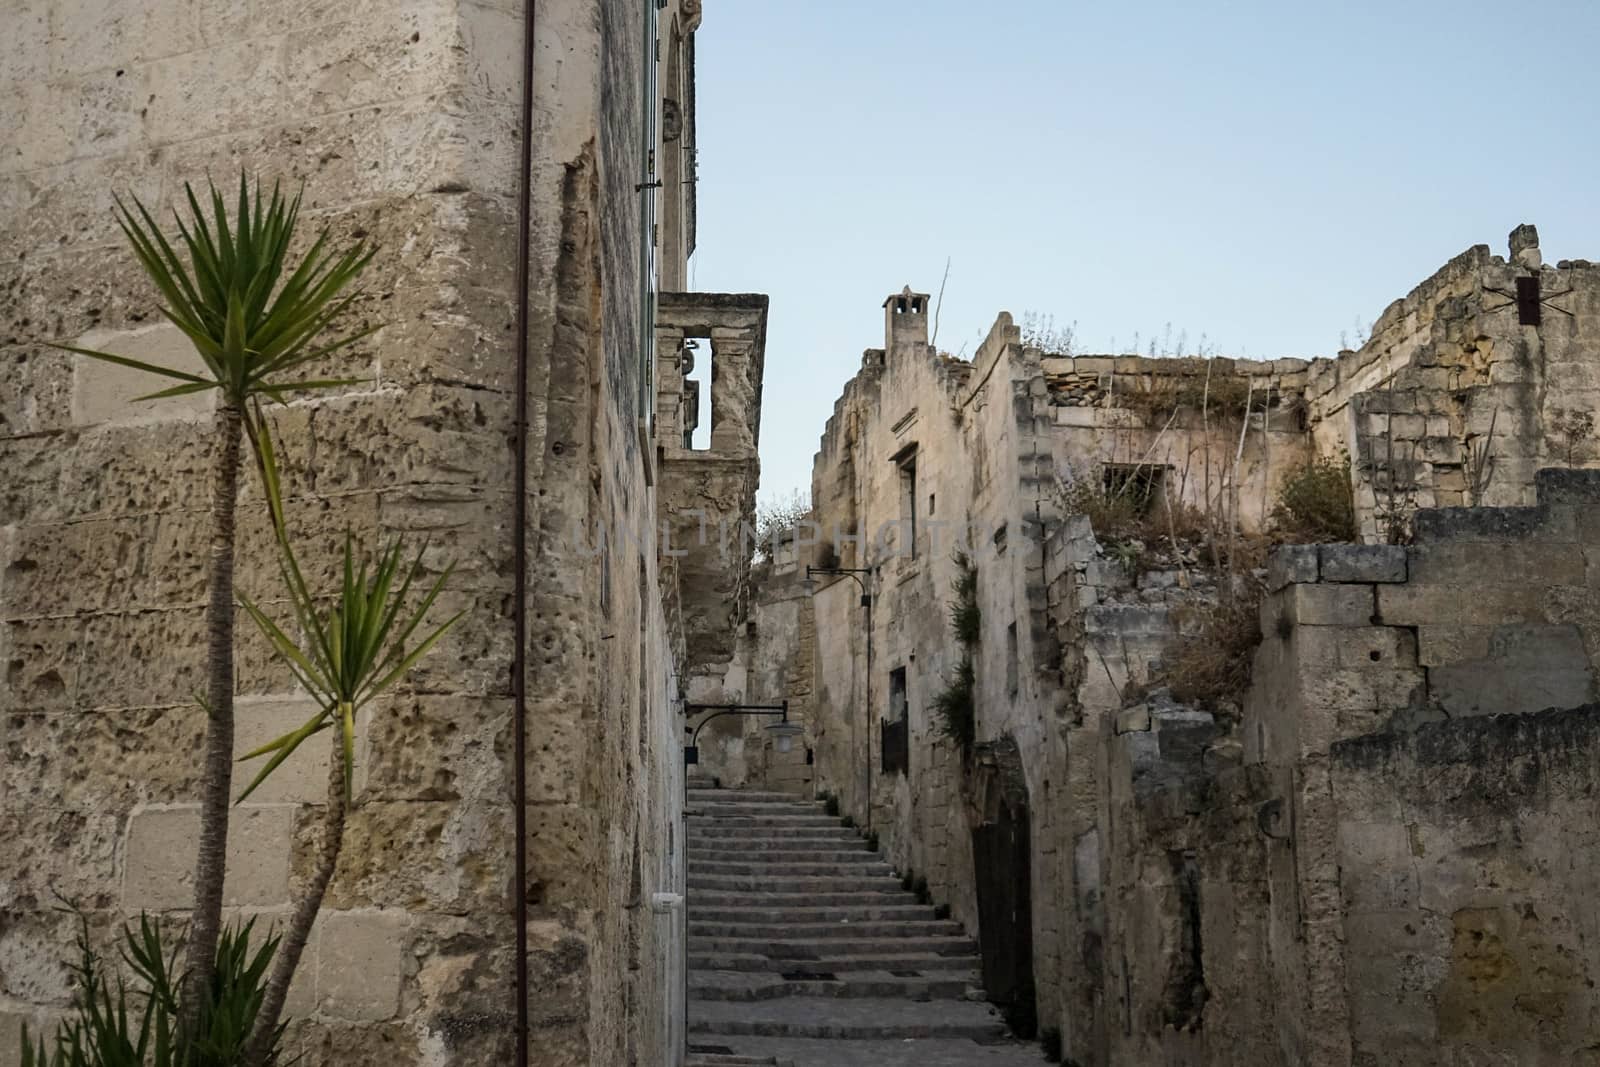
[317,910,411,1022]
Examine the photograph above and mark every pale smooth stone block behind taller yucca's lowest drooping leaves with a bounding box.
[72,323,216,426]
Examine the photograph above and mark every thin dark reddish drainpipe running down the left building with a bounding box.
[510,0,538,1067]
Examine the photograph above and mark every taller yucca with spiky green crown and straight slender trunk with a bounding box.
[56,174,378,1005]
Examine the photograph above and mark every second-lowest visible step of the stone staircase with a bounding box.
[690,997,1005,1040]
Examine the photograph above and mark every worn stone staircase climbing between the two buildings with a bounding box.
[688,787,1005,1067]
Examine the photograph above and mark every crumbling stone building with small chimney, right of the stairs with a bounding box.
[738,227,1600,1065]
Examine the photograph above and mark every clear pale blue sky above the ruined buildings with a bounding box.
[693,0,1600,498]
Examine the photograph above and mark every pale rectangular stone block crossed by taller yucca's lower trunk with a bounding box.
[122,805,294,912]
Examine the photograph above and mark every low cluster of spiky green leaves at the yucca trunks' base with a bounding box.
[22,912,283,1067]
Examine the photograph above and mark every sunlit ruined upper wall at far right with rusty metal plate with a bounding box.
[1306,226,1600,541]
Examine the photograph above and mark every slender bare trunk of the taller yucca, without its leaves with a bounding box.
[184,403,242,1032]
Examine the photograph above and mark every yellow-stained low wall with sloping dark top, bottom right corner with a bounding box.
[1331,705,1600,1067]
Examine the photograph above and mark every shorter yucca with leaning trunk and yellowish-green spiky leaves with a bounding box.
[238,411,464,1067]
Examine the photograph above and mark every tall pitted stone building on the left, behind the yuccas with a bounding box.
[0,0,765,1067]
